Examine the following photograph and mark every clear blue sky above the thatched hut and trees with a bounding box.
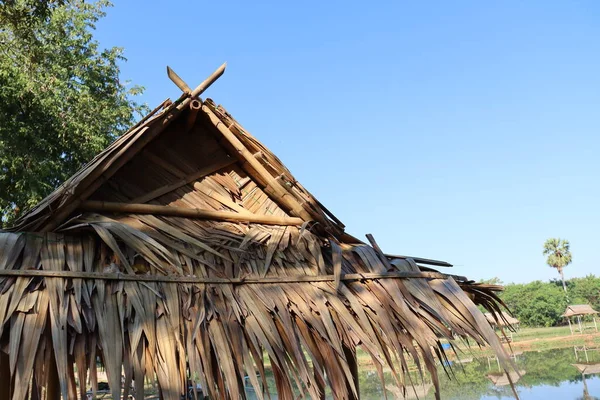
[96,0,600,282]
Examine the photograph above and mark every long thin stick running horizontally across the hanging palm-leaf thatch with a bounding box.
[0,269,467,285]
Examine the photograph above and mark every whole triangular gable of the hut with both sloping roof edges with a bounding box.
[14,67,342,236]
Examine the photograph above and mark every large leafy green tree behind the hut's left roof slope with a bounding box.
[0,0,145,224]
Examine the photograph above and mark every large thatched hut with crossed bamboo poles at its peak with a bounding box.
[0,65,512,400]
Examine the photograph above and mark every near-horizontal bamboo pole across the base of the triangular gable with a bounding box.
[80,200,304,226]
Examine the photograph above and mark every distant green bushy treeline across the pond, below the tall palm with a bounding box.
[491,275,600,326]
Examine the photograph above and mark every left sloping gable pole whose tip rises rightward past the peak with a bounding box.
[35,63,227,232]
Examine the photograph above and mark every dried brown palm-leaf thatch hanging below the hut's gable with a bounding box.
[0,214,510,400]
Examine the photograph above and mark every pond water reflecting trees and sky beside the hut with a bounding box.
[248,347,600,400]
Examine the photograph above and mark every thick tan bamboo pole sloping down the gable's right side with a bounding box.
[202,105,316,226]
